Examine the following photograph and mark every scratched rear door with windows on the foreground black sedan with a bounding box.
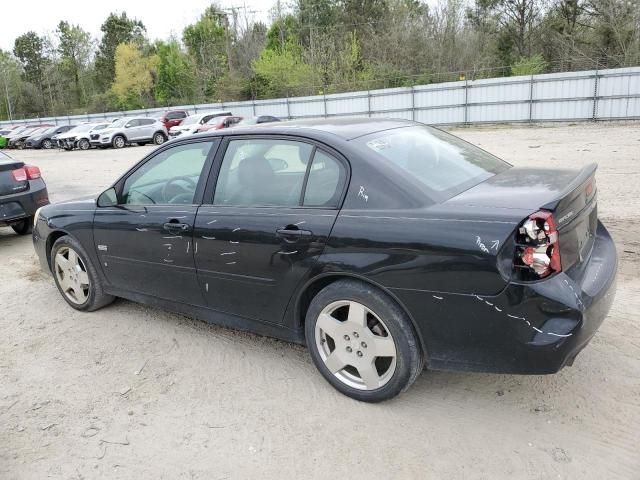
[194,136,348,323]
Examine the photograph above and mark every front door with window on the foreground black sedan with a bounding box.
[93,140,218,305]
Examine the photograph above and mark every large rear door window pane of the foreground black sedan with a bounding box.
[214,139,313,207]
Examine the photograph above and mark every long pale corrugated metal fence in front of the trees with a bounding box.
[0,67,640,125]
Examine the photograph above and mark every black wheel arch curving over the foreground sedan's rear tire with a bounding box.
[293,272,429,358]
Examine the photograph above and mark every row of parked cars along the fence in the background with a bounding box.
[0,110,280,150]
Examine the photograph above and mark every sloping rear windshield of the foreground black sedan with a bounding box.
[354,125,511,202]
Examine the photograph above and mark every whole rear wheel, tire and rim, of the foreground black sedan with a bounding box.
[305,280,424,402]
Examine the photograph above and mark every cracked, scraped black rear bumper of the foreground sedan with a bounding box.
[393,222,617,374]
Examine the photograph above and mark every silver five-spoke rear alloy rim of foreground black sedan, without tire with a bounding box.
[315,300,397,390]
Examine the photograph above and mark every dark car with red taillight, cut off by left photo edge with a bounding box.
[0,152,49,235]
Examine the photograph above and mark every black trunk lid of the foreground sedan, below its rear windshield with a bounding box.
[444,167,577,211]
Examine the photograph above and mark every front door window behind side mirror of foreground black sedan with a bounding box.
[121,142,213,205]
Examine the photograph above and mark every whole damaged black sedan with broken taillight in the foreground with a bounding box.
[33,119,617,402]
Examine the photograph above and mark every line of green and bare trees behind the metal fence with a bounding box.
[0,0,640,119]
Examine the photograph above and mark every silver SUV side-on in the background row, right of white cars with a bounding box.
[91,117,168,148]
